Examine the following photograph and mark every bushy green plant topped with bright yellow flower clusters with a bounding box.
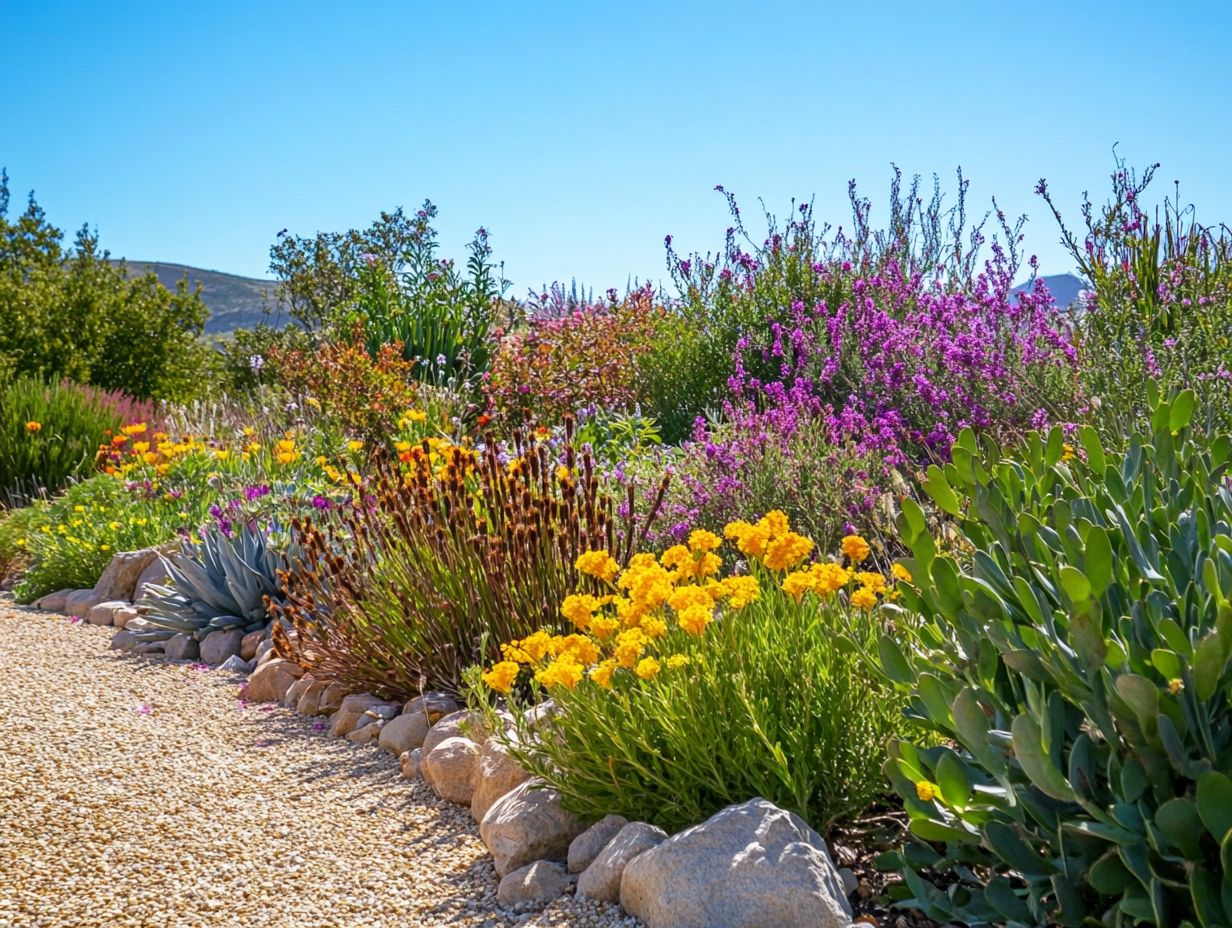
[480,511,909,829]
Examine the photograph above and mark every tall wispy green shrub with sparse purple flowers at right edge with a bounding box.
[1036,159,1232,433]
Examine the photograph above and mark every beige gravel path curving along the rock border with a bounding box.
[0,601,637,928]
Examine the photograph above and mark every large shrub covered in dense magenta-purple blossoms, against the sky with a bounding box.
[664,175,1079,542]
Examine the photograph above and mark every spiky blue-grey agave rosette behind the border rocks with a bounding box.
[140,524,298,641]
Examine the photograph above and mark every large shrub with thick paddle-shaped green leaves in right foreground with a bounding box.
[881,392,1232,926]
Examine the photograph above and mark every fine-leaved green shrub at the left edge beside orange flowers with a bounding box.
[0,377,150,503]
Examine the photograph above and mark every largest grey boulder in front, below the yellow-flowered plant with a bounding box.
[620,799,851,928]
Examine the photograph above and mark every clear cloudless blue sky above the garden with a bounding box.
[0,0,1232,296]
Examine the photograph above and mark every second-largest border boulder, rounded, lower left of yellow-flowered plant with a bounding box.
[479,779,585,876]
